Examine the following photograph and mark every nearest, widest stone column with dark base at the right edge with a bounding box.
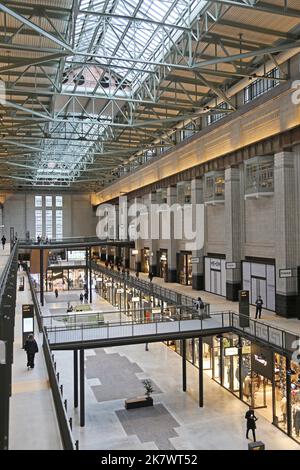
[274,152,299,317]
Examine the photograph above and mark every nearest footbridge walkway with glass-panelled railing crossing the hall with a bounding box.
[43,306,300,354]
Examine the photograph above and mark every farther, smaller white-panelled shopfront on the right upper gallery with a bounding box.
[204,256,226,297]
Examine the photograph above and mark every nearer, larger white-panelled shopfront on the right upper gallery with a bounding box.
[242,261,276,311]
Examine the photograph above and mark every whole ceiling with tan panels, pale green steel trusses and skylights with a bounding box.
[0,0,300,192]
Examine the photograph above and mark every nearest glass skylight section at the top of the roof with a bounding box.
[75,0,207,84]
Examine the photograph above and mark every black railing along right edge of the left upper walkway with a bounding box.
[28,273,76,450]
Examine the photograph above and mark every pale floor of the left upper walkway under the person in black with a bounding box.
[9,273,62,450]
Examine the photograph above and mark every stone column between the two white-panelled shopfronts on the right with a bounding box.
[225,168,241,300]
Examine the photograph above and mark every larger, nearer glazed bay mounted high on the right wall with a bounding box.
[244,156,274,199]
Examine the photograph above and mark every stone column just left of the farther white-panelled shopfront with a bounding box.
[191,179,204,290]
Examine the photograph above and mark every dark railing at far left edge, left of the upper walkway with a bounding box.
[0,243,18,450]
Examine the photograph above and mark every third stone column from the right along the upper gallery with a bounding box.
[191,179,204,290]
